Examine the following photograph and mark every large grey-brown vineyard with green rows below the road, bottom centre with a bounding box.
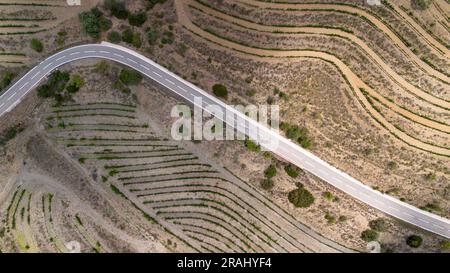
[45,103,347,252]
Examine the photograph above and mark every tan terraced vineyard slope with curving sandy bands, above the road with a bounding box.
[175,0,450,156]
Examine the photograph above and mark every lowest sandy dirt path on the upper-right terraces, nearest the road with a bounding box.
[175,1,450,156]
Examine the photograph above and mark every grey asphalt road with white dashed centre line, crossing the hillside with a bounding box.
[0,42,450,238]
